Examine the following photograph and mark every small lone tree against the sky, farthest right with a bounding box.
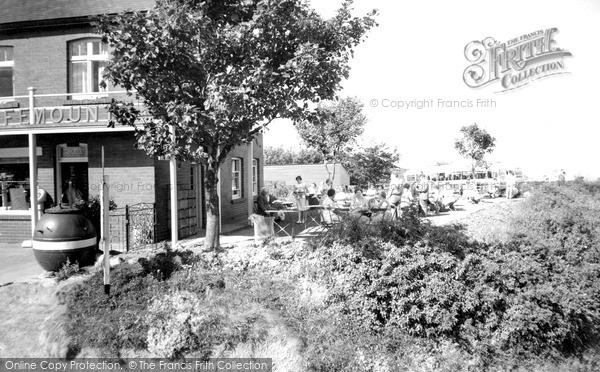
[454,123,496,178]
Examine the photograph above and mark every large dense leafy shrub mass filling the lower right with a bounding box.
[316,186,600,368]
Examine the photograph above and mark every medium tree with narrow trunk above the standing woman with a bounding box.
[295,97,367,181]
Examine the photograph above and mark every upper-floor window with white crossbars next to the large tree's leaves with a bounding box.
[69,39,108,93]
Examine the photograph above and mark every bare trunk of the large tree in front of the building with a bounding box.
[204,165,221,250]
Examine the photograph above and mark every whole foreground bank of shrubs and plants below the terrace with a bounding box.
[55,184,600,371]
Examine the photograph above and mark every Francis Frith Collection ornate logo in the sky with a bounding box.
[463,28,571,91]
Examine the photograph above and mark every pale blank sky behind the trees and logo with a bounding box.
[264,0,600,179]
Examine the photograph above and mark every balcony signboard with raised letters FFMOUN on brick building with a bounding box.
[0,105,110,128]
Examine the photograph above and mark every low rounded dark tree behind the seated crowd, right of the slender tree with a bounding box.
[343,143,400,186]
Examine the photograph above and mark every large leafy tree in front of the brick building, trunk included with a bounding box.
[97,0,376,248]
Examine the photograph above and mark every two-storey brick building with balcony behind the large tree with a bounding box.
[0,0,263,246]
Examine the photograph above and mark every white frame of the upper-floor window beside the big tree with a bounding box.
[68,38,109,99]
